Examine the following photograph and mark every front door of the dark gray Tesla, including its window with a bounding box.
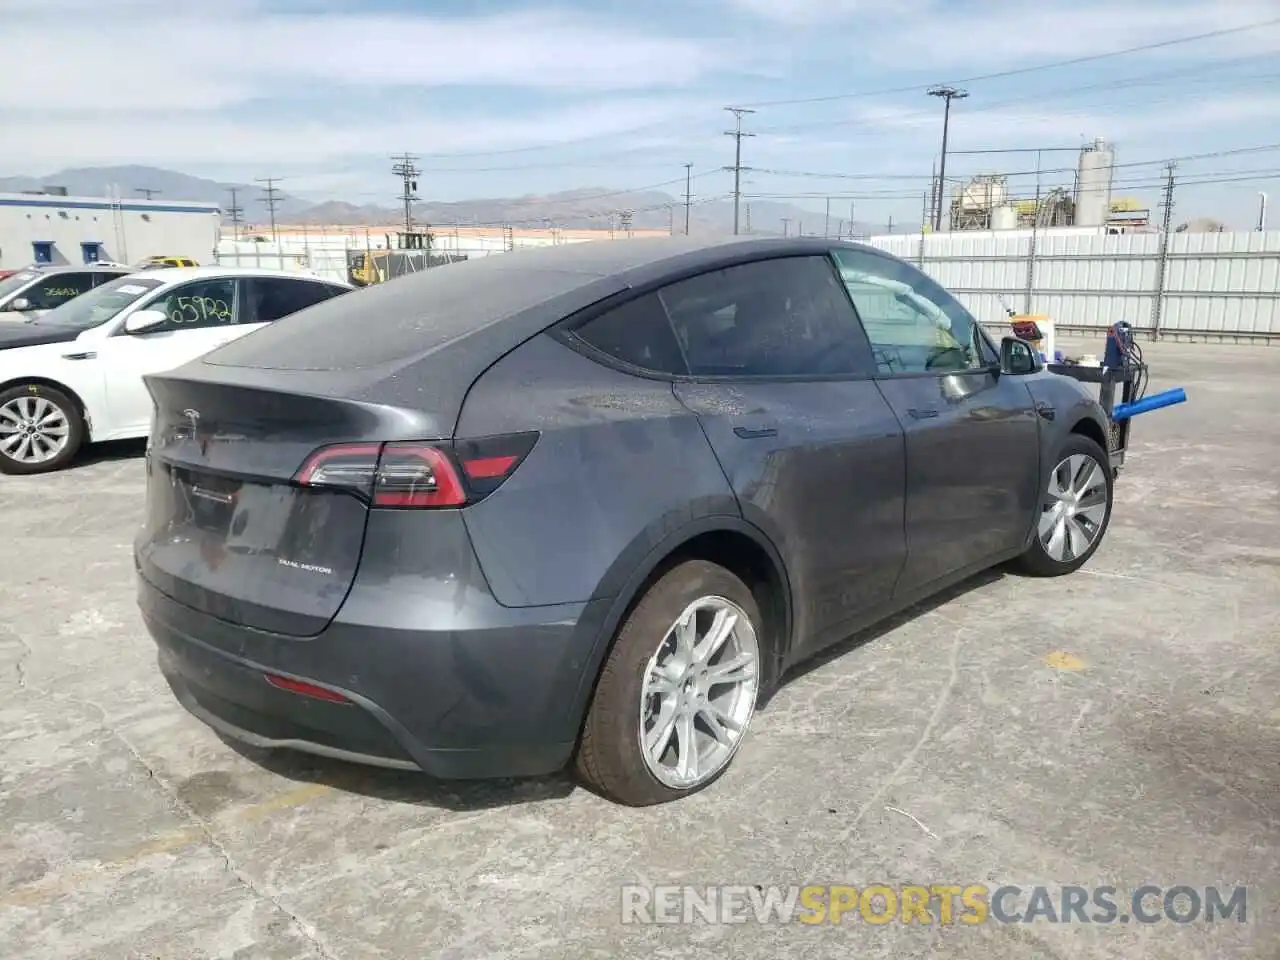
[836,250,1041,596]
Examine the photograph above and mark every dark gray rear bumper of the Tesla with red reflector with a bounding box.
[137,575,607,778]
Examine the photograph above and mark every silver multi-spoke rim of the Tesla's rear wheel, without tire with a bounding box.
[640,596,760,790]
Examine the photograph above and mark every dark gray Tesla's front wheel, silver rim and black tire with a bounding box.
[1018,434,1115,577]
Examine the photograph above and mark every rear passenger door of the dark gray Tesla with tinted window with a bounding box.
[579,255,906,648]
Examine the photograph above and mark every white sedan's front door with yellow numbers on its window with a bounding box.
[99,278,244,435]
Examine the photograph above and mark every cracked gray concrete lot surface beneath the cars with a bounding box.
[0,344,1280,960]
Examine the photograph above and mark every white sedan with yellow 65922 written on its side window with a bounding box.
[0,266,353,474]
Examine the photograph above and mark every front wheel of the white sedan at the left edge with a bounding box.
[0,383,84,474]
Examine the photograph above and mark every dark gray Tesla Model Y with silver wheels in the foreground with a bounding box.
[136,238,1112,805]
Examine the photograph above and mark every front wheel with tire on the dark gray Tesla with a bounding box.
[1015,434,1115,577]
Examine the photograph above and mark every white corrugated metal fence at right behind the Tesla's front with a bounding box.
[868,230,1280,342]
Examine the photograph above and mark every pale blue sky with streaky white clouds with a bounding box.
[0,0,1280,227]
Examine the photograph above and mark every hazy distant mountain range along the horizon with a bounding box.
[0,166,919,236]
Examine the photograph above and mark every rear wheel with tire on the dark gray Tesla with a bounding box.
[576,559,765,806]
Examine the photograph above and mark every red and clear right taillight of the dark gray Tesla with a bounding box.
[293,433,538,508]
